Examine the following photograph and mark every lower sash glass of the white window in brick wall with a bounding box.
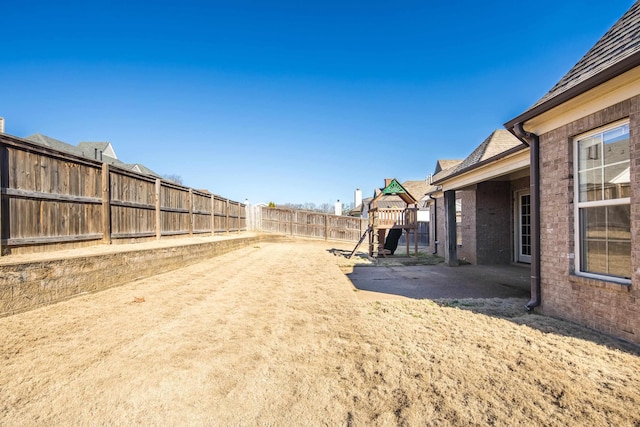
[580,205,631,278]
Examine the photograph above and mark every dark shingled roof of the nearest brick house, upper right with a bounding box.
[505,2,640,129]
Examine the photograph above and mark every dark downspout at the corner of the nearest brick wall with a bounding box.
[513,122,541,311]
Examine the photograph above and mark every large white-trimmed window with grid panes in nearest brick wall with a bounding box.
[574,122,631,282]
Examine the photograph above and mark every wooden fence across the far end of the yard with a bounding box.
[260,207,368,242]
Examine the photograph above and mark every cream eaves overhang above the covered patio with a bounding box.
[433,145,530,191]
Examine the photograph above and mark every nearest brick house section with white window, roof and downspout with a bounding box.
[505,3,640,343]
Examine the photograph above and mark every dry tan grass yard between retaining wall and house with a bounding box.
[0,242,640,426]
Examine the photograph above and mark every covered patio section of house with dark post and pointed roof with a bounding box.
[430,129,531,265]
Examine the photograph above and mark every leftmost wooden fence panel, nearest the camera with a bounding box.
[2,146,102,252]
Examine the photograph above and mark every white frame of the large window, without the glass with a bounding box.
[572,119,633,285]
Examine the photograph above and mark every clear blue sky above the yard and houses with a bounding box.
[0,0,633,205]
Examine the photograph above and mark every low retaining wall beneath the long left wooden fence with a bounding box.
[0,235,286,316]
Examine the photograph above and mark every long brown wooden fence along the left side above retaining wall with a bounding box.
[0,134,246,255]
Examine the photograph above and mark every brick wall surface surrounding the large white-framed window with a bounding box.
[540,97,640,343]
